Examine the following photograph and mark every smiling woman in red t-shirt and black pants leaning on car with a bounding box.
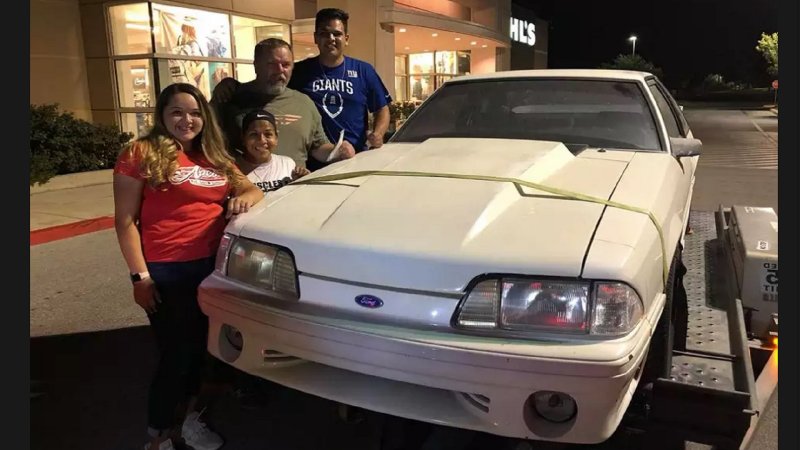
[114,83,263,450]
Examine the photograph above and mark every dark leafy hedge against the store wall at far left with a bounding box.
[30,104,133,186]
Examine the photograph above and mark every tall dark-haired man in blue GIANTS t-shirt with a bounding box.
[289,8,392,170]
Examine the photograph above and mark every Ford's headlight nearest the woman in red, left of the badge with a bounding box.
[216,234,299,300]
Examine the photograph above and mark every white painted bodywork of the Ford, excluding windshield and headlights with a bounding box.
[199,70,697,443]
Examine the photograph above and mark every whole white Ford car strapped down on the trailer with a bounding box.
[200,70,701,443]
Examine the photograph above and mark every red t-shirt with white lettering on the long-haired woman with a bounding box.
[114,144,230,262]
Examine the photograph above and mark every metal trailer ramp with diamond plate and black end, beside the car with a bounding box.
[647,211,758,449]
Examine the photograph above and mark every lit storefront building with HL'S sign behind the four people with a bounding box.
[30,0,547,134]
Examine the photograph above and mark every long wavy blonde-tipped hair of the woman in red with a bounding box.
[125,83,241,188]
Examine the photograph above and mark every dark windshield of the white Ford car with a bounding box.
[391,78,662,150]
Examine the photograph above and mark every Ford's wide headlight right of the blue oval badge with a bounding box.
[453,278,644,336]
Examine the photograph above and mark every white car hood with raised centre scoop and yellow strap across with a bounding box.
[234,138,632,294]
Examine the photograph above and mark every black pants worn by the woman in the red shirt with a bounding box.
[147,257,214,436]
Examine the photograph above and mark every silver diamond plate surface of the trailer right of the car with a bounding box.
[683,211,731,355]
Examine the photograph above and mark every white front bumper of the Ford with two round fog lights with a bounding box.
[199,273,651,443]
